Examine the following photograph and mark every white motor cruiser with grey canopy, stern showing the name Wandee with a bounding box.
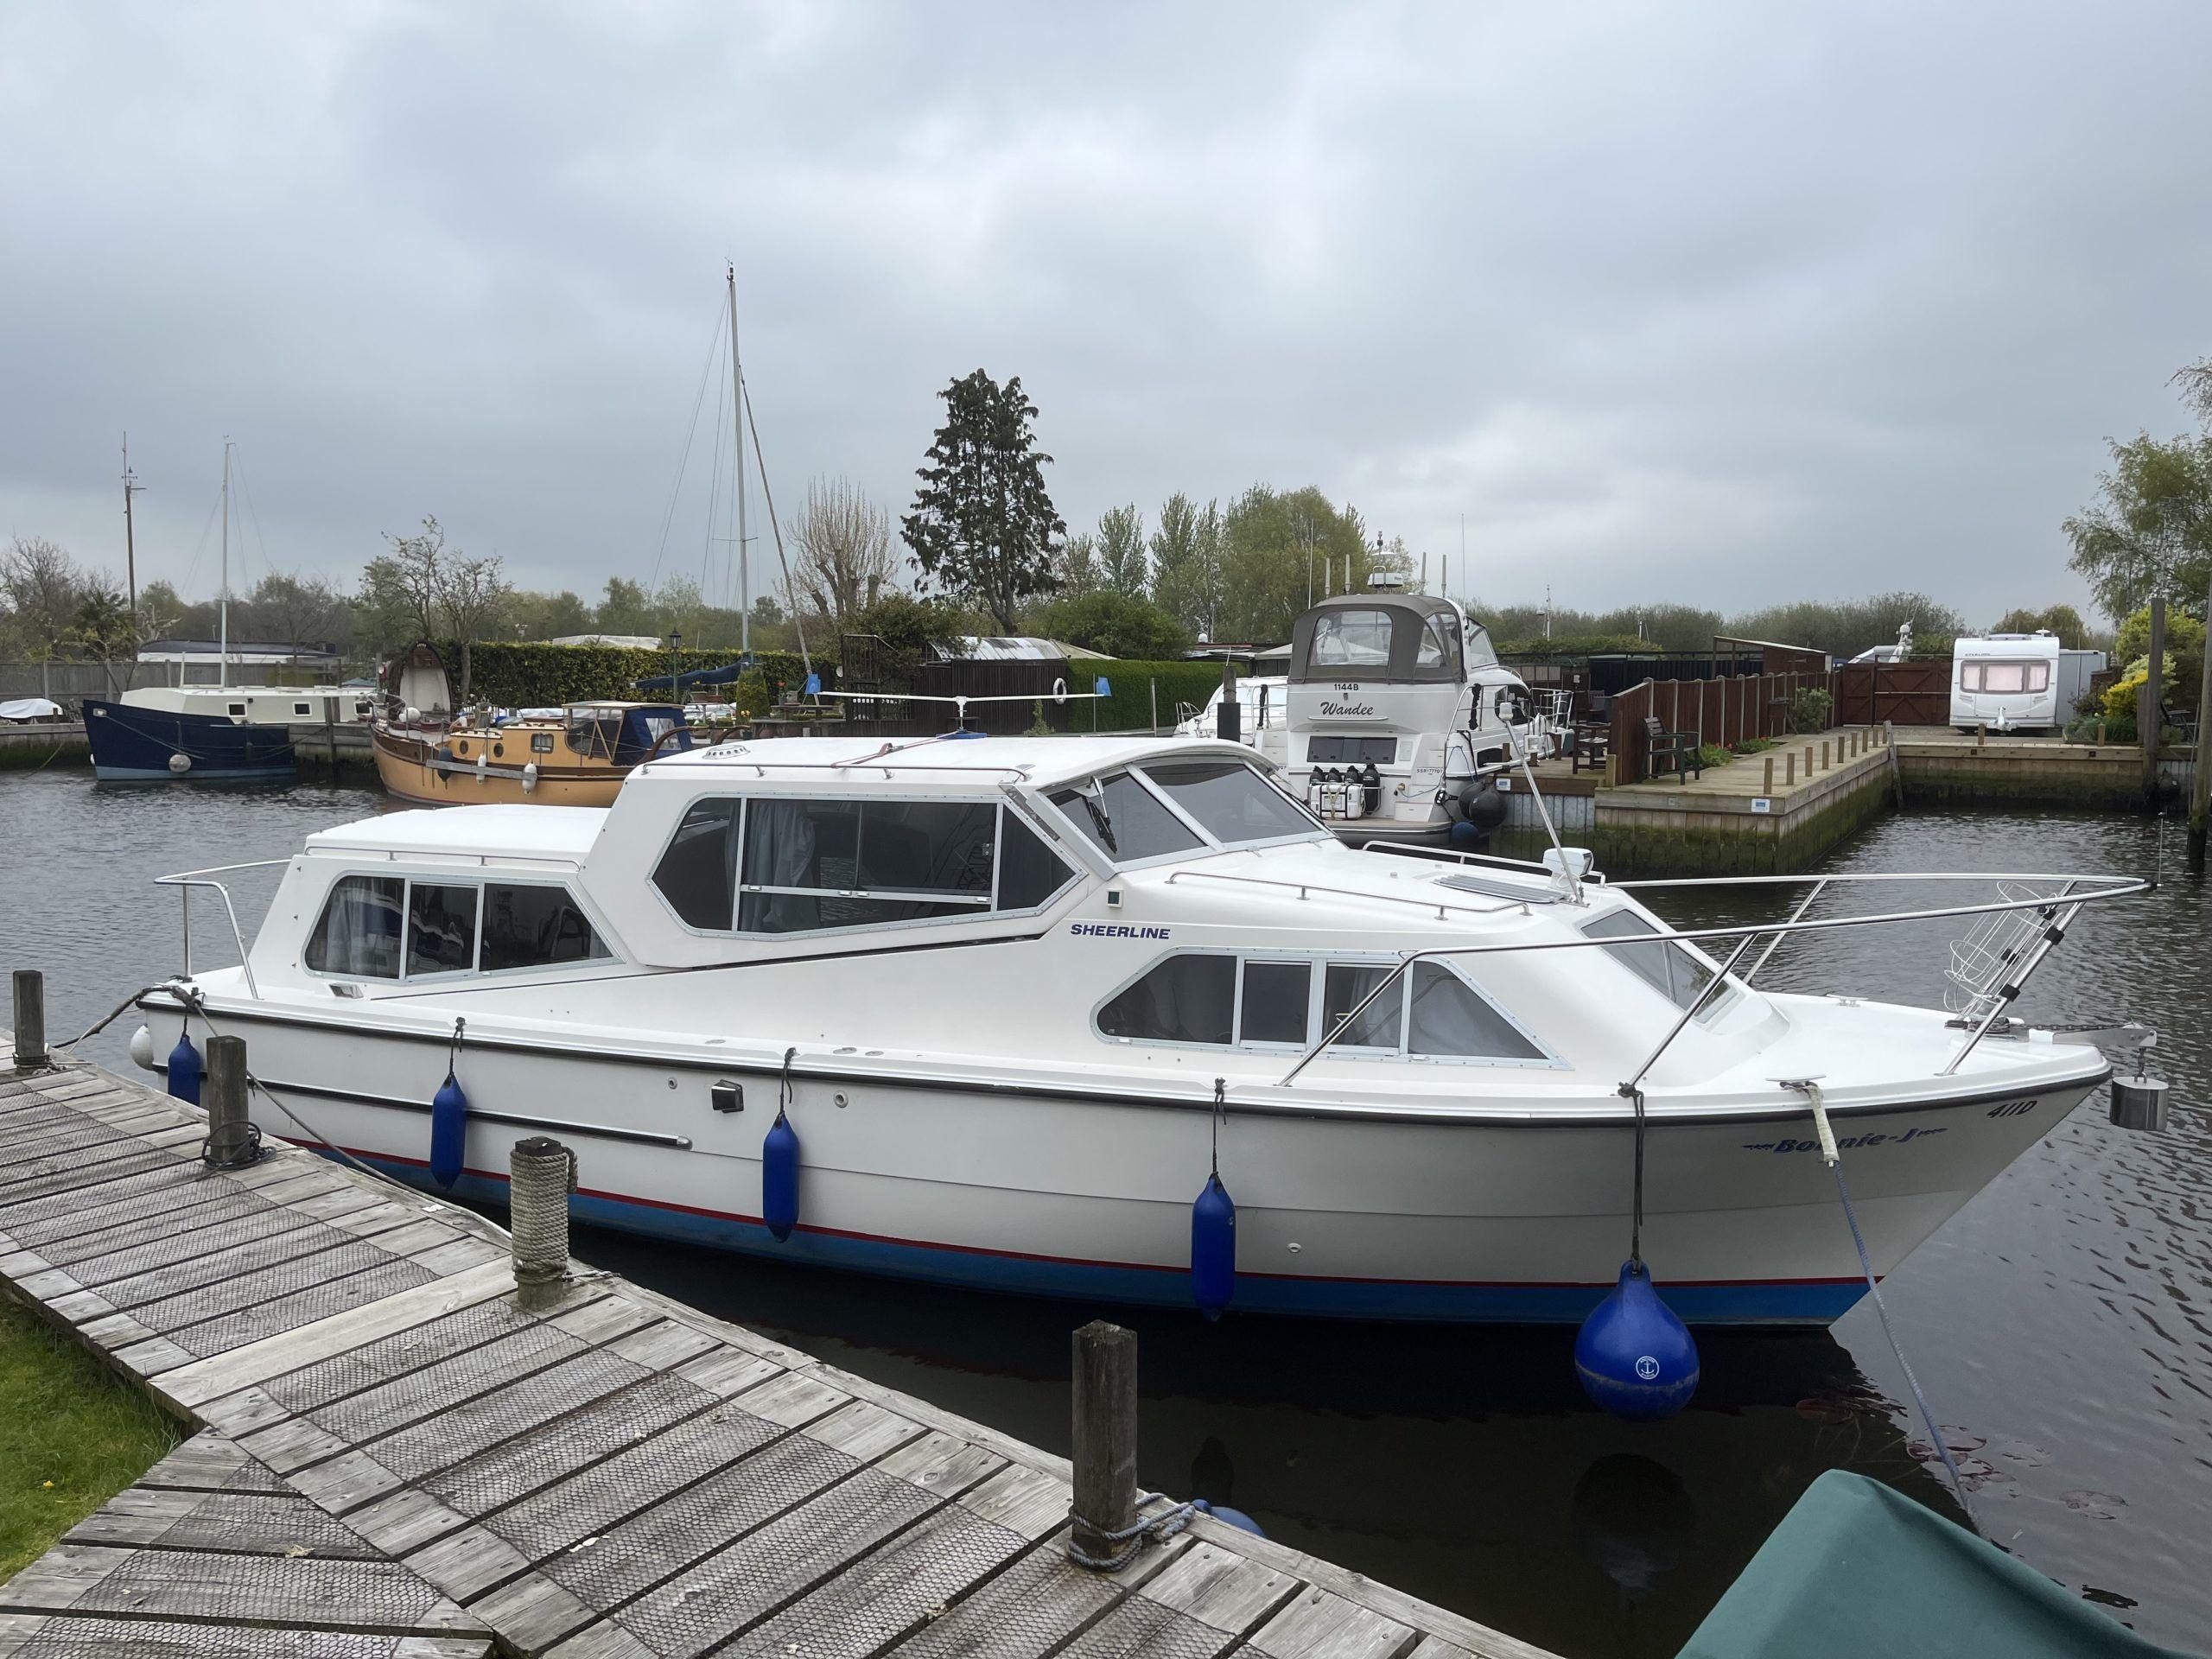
[1283,591,1553,845]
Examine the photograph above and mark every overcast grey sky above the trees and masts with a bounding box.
[0,0,2212,621]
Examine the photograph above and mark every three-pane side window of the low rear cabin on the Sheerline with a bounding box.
[303,876,608,980]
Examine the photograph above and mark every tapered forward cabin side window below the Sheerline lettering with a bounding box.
[1097,951,1553,1066]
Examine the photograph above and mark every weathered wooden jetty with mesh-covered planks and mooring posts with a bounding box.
[0,991,1551,1659]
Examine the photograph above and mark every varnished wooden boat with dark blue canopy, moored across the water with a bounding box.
[372,703,692,807]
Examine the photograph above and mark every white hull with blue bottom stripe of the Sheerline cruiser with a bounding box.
[142,995,2101,1325]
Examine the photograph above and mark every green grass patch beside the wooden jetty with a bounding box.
[0,1300,181,1580]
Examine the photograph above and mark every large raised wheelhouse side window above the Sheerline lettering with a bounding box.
[652,797,1073,933]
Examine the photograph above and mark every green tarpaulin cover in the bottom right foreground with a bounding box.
[1679,1469,2192,1659]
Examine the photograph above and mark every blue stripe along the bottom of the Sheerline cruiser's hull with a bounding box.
[321,1153,1867,1325]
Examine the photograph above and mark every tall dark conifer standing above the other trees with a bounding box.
[900,370,1068,632]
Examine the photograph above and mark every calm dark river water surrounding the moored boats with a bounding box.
[0,772,2212,1659]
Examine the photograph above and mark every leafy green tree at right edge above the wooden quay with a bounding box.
[2066,435,2212,621]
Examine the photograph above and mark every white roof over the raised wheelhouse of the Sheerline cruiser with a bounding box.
[639,734,1263,787]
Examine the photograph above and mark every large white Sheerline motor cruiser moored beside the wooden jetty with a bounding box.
[135,739,2141,1323]
